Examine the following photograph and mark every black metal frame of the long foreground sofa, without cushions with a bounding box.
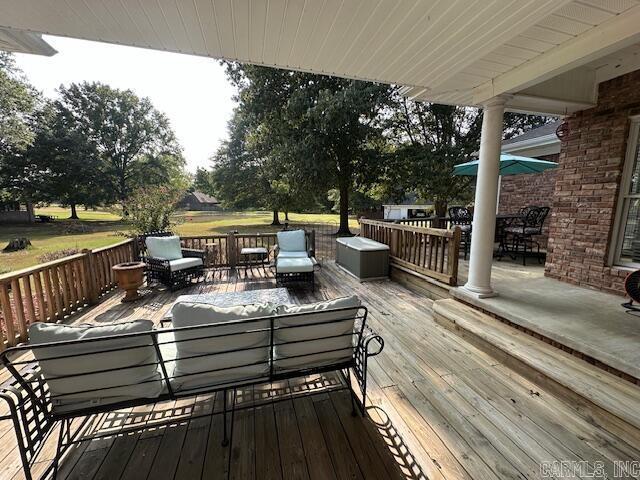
[0,307,384,480]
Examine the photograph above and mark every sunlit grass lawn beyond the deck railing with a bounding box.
[0,207,358,274]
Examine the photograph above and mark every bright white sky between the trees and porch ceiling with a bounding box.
[16,36,240,172]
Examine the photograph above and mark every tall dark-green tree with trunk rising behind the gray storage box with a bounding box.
[220,63,389,233]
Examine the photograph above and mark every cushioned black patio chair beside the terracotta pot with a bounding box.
[142,232,206,291]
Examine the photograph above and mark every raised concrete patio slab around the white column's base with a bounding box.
[451,261,640,378]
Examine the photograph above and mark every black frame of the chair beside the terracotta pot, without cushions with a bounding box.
[138,231,206,291]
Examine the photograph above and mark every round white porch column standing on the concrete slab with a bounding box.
[464,97,506,298]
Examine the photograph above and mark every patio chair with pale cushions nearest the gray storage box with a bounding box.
[275,230,320,288]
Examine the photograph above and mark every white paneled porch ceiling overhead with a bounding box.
[0,0,640,109]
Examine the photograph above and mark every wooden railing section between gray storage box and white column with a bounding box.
[360,219,460,285]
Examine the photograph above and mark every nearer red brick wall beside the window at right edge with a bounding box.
[545,70,640,294]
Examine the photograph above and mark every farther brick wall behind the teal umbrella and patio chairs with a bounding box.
[498,154,559,248]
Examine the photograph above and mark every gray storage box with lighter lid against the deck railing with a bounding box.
[336,237,389,280]
